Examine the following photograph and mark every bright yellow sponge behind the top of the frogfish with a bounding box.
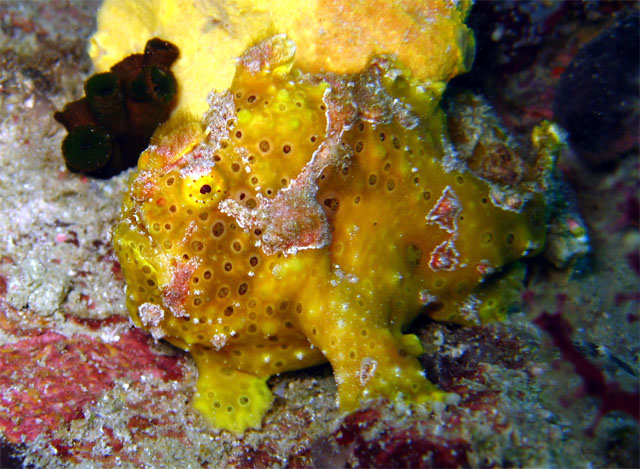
[89,0,474,116]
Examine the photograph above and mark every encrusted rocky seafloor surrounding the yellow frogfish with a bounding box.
[0,0,640,468]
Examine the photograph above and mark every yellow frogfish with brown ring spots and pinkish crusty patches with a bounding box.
[114,36,544,433]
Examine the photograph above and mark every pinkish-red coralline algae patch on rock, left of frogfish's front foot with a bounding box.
[0,303,183,443]
